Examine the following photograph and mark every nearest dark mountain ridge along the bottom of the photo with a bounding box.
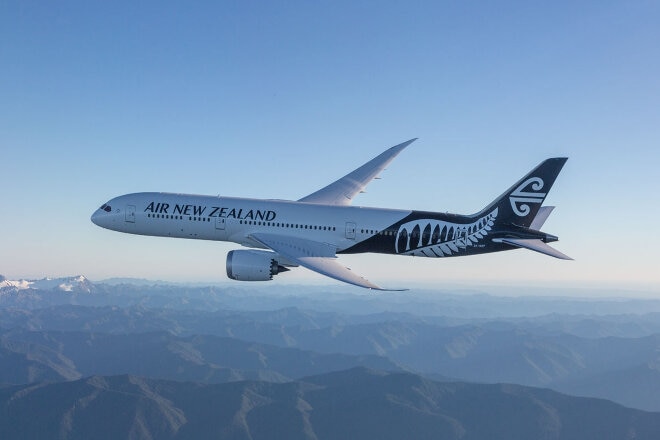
[0,368,660,440]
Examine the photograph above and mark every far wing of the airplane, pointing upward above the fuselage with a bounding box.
[298,138,417,205]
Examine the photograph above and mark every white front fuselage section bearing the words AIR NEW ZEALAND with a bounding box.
[92,192,411,252]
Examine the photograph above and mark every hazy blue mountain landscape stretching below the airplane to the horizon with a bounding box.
[0,276,660,438]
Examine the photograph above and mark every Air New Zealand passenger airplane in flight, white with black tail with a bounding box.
[91,138,571,290]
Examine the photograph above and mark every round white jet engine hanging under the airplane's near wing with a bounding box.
[227,250,289,281]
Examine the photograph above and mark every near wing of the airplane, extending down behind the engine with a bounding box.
[250,233,403,290]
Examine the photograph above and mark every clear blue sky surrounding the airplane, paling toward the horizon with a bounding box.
[0,1,660,291]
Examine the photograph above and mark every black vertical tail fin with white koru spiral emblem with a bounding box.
[475,157,568,228]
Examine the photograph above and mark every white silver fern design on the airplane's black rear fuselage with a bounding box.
[395,208,497,257]
